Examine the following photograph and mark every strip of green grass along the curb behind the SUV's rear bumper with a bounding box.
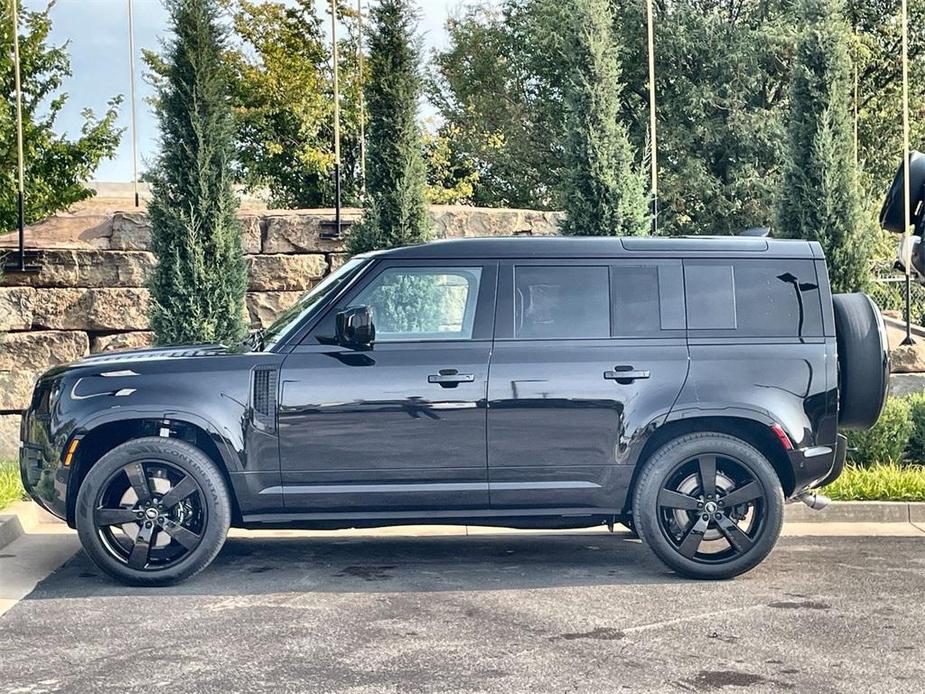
[823,463,925,501]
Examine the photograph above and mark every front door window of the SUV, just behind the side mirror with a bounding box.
[351,267,482,342]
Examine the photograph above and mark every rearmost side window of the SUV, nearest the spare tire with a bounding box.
[684,260,823,337]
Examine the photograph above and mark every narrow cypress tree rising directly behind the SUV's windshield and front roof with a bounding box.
[349,0,430,253]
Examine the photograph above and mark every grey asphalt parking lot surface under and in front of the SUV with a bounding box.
[0,532,925,694]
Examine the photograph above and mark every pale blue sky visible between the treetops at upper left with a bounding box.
[22,0,480,181]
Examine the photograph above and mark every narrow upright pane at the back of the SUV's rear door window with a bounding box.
[613,265,662,337]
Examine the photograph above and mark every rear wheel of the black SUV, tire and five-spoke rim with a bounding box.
[633,432,784,579]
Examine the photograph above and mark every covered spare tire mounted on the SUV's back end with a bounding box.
[832,294,890,429]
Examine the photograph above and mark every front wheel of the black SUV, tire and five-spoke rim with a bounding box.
[75,437,231,586]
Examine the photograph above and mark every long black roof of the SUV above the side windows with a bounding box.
[375,236,823,260]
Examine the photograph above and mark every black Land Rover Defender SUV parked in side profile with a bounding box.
[21,238,888,585]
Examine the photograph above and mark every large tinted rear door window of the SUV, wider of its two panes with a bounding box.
[514,265,610,338]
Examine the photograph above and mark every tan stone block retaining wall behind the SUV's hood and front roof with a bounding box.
[0,206,560,459]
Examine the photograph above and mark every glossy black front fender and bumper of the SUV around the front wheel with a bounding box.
[21,354,280,518]
